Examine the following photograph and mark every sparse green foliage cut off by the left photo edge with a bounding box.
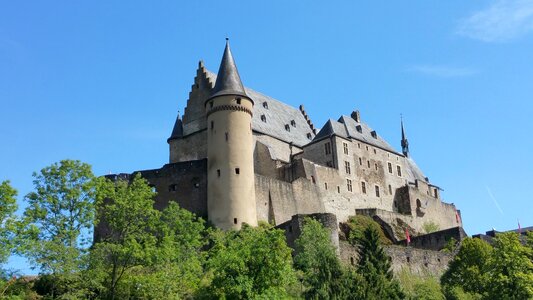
[0,181,17,266]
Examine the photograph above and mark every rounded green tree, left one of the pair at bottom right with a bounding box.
[441,238,492,295]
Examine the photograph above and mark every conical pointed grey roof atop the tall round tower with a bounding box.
[208,38,248,100]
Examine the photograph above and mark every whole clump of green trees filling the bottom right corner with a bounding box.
[441,232,533,299]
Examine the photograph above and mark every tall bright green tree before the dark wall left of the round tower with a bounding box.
[88,173,161,299]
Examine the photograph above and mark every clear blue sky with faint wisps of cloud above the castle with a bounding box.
[0,0,533,270]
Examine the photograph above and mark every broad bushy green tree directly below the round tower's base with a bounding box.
[203,224,296,299]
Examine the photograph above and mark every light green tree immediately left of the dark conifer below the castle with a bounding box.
[294,218,361,299]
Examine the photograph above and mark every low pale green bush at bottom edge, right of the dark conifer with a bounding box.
[398,268,445,300]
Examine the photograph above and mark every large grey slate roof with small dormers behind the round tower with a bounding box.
[206,71,315,147]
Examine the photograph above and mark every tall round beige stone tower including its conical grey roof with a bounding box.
[205,39,257,230]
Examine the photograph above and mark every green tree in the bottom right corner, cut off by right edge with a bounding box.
[486,232,533,299]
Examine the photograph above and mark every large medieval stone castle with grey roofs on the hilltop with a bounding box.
[101,38,462,272]
